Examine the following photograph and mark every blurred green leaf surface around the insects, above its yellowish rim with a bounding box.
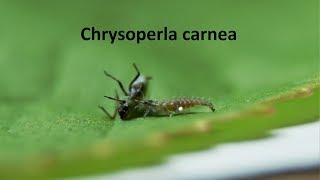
[0,0,319,172]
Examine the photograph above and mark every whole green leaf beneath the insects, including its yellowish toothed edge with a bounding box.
[0,0,320,177]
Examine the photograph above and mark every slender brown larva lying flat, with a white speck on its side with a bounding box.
[136,97,215,117]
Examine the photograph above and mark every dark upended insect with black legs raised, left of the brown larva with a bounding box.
[99,63,151,120]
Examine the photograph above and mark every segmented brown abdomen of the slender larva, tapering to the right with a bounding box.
[158,98,215,112]
